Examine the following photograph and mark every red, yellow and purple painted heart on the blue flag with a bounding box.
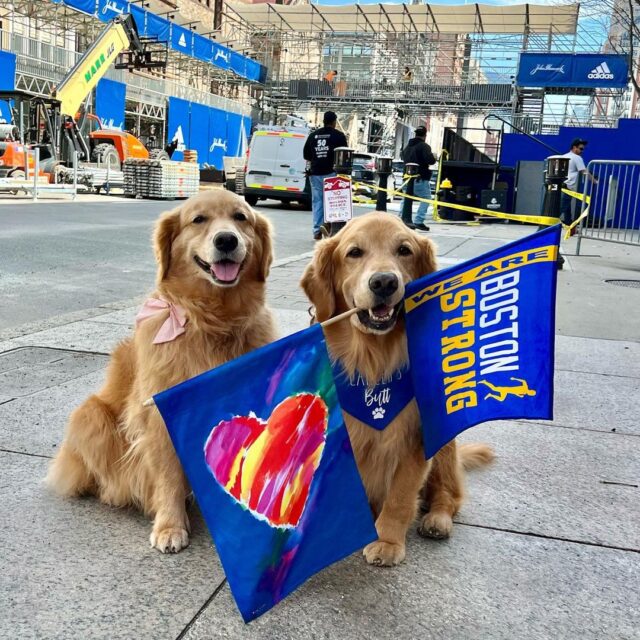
[204,393,328,527]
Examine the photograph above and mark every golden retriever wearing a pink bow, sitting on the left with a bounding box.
[47,191,276,553]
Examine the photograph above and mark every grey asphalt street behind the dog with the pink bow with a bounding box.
[0,198,313,335]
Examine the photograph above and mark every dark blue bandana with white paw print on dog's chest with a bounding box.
[332,362,415,431]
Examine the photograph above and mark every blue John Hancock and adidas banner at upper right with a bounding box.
[516,53,629,89]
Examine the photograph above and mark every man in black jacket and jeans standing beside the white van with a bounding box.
[302,111,347,240]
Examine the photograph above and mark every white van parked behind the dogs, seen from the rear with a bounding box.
[243,127,311,208]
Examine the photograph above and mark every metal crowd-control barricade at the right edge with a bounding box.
[576,160,640,255]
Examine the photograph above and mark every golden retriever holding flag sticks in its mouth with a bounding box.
[301,212,493,566]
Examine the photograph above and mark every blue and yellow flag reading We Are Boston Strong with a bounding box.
[405,225,560,458]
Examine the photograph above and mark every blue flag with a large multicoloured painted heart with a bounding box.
[154,326,376,621]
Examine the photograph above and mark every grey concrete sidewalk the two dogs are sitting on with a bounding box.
[0,225,640,640]
